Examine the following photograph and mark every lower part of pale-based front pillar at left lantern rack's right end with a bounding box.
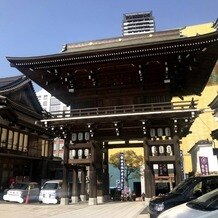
[89,164,97,205]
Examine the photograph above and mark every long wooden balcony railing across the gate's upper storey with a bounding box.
[48,101,197,118]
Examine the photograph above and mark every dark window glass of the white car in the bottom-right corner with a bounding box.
[187,189,218,211]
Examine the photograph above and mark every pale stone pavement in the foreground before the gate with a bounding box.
[0,201,149,218]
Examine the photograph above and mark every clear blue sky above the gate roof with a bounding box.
[0,0,218,77]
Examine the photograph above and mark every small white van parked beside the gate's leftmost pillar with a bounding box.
[39,180,63,204]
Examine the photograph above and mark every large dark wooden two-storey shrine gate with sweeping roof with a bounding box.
[7,21,218,204]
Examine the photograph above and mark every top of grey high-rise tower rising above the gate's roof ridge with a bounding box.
[123,11,155,36]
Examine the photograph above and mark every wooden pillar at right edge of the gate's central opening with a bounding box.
[143,139,155,198]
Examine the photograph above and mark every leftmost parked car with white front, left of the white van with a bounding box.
[3,182,40,203]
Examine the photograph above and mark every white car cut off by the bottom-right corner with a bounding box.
[158,188,218,218]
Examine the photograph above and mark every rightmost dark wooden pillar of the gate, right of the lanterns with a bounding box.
[173,135,182,185]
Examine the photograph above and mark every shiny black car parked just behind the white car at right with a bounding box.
[149,175,218,218]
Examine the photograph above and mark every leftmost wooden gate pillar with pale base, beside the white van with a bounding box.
[61,140,69,205]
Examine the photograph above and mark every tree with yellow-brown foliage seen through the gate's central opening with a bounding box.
[109,150,144,187]
